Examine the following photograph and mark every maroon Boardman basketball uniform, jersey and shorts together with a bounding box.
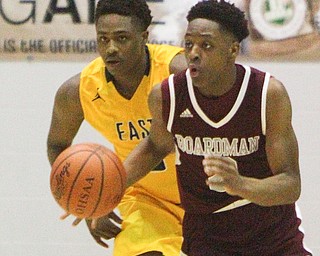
[162,64,309,255]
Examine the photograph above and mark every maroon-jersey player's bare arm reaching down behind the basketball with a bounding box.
[124,85,174,187]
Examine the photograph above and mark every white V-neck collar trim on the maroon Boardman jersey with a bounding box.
[186,65,251,128]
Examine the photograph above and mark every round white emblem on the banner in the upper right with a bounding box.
[249,0,307,41]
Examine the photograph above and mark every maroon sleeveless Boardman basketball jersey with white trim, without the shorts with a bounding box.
[162,65,272,213]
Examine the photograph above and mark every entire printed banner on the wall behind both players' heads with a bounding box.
[0,0,320,61]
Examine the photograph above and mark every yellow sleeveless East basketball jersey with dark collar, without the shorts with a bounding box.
[80,44,182,203]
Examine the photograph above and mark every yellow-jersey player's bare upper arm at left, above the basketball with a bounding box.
[47,74,83,165]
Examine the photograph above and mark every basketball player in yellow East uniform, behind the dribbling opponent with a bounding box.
[47,0,187,256]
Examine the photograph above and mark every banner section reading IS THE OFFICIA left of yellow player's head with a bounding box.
[0,0,97,60]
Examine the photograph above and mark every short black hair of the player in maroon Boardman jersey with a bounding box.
[187,0,249,42]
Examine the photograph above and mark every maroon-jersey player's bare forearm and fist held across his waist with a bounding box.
[203,152,301,206]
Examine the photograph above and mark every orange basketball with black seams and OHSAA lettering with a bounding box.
[50,143,126,218]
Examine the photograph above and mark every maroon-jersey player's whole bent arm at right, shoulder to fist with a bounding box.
[203,78,301,206]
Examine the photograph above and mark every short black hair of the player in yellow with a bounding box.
[95,0,152,30]
